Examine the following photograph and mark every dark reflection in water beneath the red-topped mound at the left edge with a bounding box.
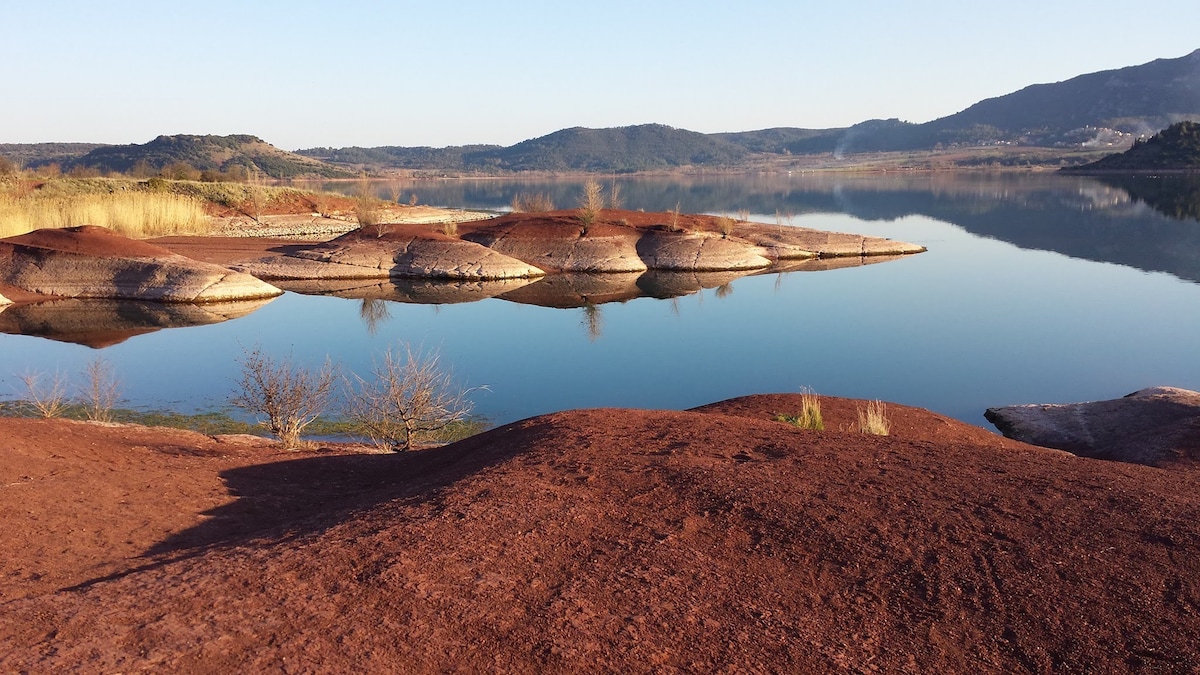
[0,298,274,350]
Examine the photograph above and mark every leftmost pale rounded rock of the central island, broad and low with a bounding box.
[238,232,545,280]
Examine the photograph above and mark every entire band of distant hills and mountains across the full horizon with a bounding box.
[0,49,1200,178]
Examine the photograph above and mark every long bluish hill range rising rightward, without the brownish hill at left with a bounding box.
[300,49,1200,173]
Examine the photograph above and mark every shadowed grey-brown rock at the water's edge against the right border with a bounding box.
[984,387,1200,467]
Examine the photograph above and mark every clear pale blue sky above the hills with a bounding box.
[0,0,1200,150]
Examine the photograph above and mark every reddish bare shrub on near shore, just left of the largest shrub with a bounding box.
[230,347,337,448]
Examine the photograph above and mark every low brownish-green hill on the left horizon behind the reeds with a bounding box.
[67,135,354,178]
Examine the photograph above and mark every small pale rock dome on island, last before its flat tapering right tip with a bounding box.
[637,229,770,271]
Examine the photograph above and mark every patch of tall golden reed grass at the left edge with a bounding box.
[0,191,209,239]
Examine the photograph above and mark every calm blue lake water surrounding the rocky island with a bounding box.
[0,174,1200,426]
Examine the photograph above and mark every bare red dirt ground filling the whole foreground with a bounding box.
[0,396,1200,673]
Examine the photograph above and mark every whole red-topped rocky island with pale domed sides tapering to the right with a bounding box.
[235,209,924,280]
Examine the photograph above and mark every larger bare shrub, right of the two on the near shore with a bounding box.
[346,344,486,453]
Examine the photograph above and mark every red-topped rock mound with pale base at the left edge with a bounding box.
[0,226,282,303]
